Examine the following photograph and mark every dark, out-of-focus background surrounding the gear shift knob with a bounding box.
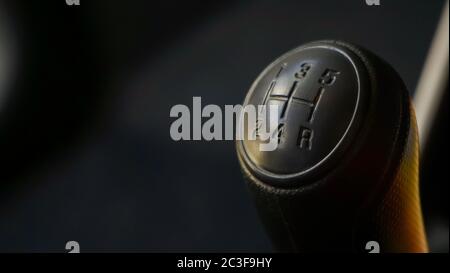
[0,0,448,252]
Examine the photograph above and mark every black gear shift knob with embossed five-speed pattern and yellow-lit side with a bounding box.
[236,41,427,252]
